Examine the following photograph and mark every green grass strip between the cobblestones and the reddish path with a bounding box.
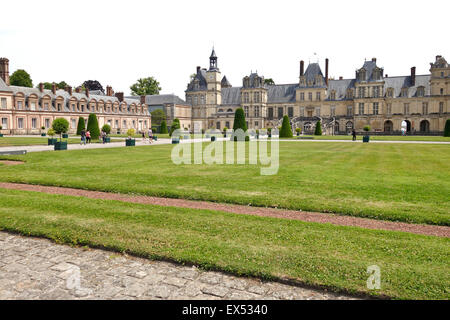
[0,189,450,299]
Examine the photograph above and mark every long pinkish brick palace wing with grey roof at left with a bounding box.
[0,58,151,134]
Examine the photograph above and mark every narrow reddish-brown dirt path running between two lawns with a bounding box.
[0,182,450,238]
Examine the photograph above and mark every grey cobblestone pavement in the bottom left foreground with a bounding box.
[0,232,354,300]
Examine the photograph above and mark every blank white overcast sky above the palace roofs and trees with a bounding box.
[0,0,450,99]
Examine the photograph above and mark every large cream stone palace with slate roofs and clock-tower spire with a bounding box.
[185,49,450,134]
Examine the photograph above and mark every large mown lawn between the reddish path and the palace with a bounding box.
[0,142,450,225]
